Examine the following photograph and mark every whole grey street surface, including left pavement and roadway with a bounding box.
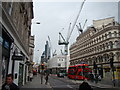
[21,74,119,90]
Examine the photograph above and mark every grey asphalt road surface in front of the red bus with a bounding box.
[49,76,118,90]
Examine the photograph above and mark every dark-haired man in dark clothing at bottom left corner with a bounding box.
[1,74,19,90]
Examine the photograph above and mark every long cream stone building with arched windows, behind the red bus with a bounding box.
[70,17,120,84]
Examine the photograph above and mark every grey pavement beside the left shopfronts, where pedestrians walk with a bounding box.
[21,74,52,89]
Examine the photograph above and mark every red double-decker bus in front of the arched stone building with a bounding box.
[68,64,91,80]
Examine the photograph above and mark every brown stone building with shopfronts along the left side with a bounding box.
[0,0,33,86]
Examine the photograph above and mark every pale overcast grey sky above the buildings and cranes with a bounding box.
[32,0,118,62]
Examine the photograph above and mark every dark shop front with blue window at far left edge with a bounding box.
[0,25,13,83]
